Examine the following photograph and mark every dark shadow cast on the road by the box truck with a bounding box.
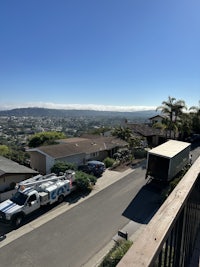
[122,182,166,224]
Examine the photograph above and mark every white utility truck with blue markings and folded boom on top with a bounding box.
[0,171,76,228]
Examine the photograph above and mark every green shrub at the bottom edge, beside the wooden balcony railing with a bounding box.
[99,240,133,267]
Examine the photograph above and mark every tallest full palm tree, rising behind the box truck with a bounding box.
[156,96,187,138]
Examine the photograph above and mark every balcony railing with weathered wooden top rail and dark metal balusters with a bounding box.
[117,157,200,267]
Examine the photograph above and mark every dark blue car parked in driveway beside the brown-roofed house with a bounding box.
[78,160,105,177]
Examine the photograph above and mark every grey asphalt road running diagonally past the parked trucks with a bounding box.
[0,168,154,267]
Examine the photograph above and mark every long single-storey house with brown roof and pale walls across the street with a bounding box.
[27,136,128,174]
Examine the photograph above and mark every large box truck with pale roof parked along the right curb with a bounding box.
[146,140,191,182]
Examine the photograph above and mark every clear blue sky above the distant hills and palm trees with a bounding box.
[0,0,200,110]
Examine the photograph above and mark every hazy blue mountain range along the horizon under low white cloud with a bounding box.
[0,107,158,119]
